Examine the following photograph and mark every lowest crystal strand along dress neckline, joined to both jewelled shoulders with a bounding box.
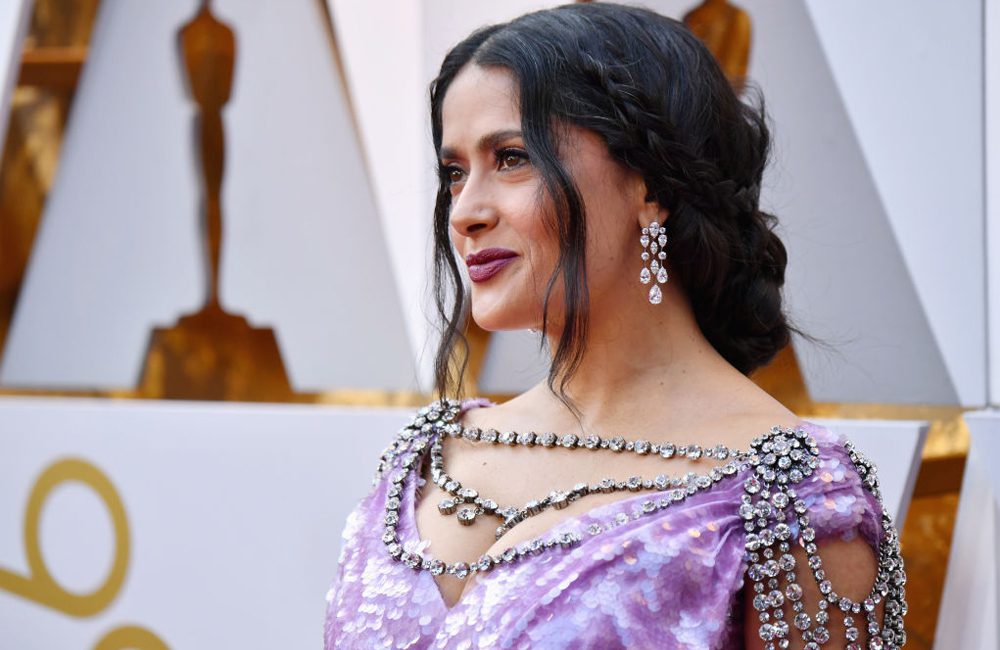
[372,400,907,650]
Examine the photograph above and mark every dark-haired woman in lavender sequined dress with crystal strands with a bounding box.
[325,3,905,648]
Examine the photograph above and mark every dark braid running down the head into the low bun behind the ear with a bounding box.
[571,33,789,373]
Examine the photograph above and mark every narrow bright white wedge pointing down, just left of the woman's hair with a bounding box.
[327,0,434,385]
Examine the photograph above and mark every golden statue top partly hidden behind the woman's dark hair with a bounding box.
[684,0,751,94]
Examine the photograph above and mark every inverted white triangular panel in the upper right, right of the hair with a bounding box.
[806,0,986,404]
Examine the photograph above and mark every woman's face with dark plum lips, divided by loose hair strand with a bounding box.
[440,64,658,331]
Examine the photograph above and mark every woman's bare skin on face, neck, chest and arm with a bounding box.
[416,64,874,647]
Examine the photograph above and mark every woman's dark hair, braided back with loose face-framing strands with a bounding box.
[430,3,812,412]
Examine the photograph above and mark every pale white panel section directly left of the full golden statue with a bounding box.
[0,0,204,388]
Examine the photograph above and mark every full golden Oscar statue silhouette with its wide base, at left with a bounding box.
[139,0,294,401]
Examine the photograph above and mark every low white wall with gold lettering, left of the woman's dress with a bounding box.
[0,398,412,650]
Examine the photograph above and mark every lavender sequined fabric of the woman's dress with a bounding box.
[324,398,891,650]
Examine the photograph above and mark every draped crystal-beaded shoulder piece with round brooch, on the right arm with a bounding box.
[739,429,906,650]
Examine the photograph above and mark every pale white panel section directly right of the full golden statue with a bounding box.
[213,0,416,390]
